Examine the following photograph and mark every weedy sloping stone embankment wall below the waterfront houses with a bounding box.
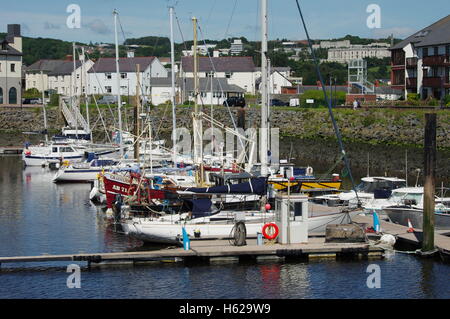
[0,106,450,149]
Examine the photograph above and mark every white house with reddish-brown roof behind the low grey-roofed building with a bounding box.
[180,56,256,94]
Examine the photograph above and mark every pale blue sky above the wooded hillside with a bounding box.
[0,0,450,43]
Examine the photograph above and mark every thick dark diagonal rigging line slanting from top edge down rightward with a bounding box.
[295,0,361,206]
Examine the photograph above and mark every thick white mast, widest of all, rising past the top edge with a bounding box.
[260,0,268,176]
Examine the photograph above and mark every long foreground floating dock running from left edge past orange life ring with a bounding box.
[0,237,384,267]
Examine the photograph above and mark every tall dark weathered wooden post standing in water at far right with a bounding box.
[421,113,436,254]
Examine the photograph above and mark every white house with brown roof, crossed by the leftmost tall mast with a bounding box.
[88,57,169,95]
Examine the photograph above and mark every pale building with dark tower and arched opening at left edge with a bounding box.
[0,24,22,105]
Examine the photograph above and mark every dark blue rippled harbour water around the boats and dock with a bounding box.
[0,142,450,299]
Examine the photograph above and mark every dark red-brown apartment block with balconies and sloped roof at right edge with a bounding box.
[390,15,450,99]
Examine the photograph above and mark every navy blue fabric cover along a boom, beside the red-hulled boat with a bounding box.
[186,177,267,195]
